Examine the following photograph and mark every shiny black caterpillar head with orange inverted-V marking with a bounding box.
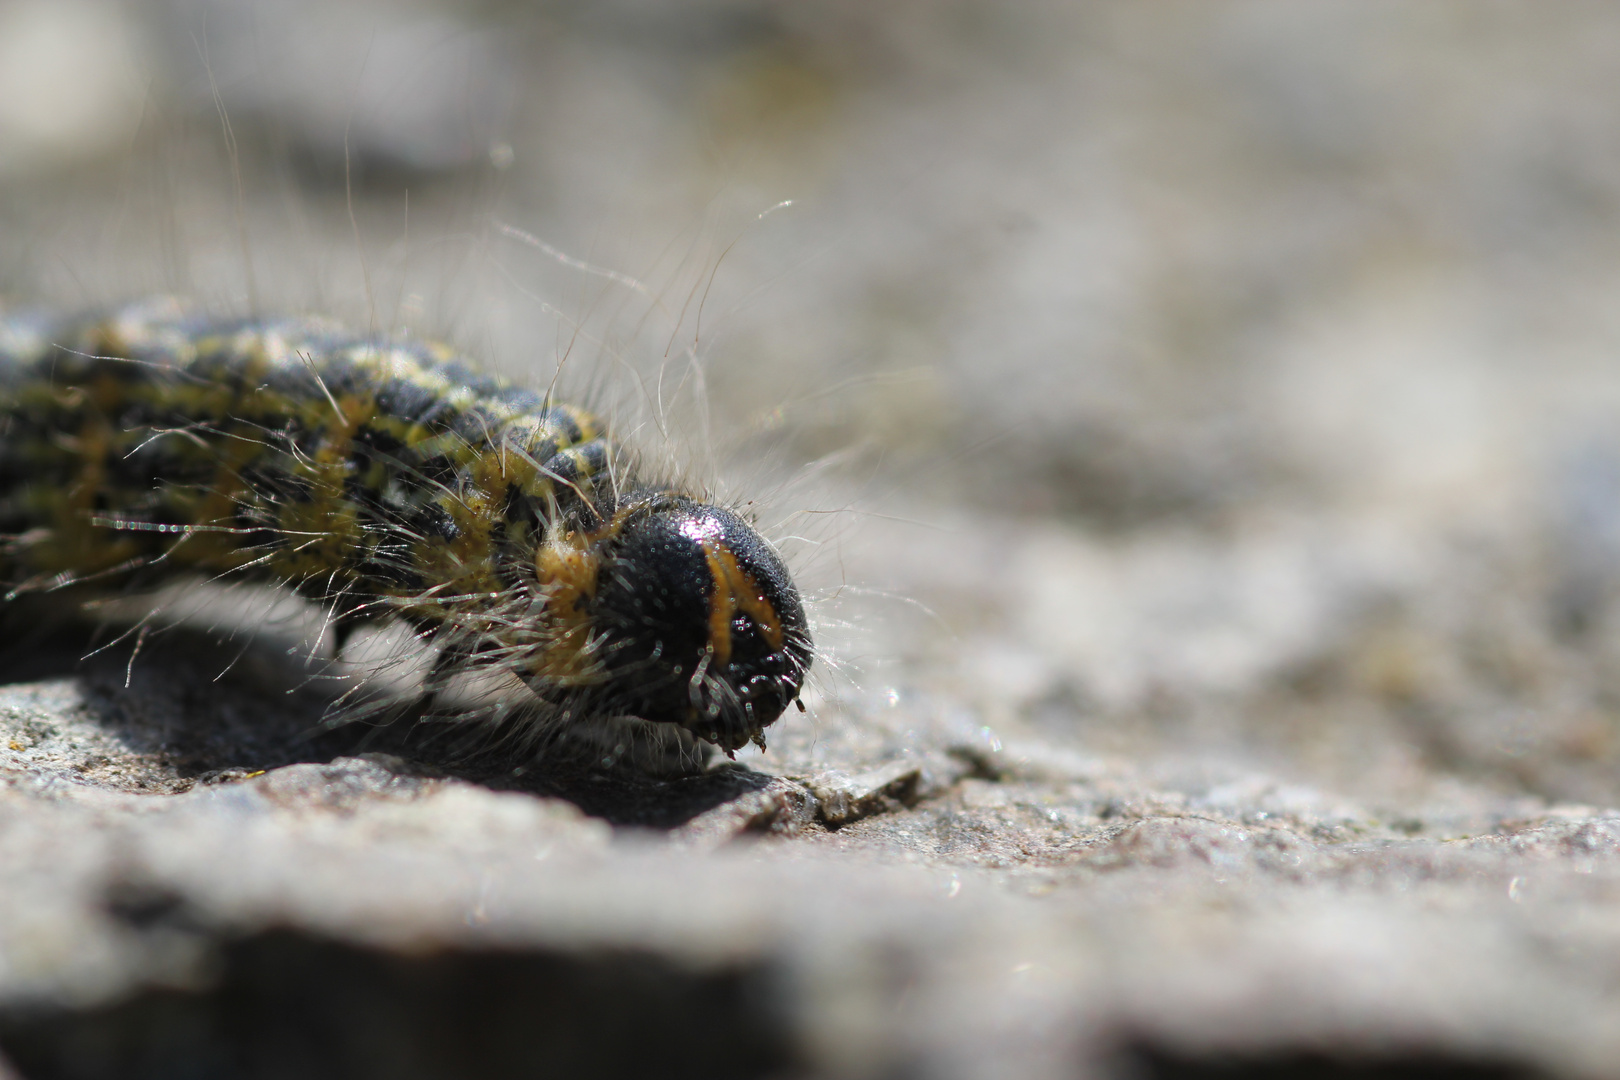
[590,494,812,753]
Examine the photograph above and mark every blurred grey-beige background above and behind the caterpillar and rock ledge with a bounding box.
[0,0,1620,813]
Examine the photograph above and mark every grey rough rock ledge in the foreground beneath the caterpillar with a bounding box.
[0,615,1620,1077]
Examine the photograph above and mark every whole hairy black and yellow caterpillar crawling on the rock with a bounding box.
[0,298,812,767]
